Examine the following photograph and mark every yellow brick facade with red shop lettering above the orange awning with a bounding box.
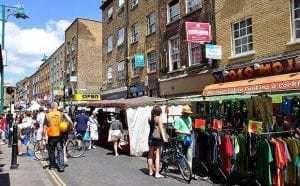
[215,0,300,81]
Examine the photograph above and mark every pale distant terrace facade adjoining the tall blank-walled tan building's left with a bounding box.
[48,43,65,102]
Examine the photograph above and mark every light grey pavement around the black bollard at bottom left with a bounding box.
[0,145,53,186]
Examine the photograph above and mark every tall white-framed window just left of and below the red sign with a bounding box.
[169,36,180,72]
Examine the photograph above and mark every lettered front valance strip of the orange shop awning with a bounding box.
[207,80,300,95]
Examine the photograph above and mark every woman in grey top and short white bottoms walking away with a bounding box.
[110,115,123,157]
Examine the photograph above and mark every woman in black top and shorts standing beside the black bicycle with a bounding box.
[148,106,167,178]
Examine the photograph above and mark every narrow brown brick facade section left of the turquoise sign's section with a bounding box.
[100,0,128,99]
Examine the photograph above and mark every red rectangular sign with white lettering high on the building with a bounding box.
[185,22,211,43]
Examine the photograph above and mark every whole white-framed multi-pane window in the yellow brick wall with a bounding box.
[232,18,253,55]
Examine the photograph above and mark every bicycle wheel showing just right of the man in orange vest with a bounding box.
[66,131,87,158]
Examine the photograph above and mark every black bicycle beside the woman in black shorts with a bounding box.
[160,138,192,183]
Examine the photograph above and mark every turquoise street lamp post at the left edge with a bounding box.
[0,4,29,113]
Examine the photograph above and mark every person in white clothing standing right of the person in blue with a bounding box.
[88,110,100,149]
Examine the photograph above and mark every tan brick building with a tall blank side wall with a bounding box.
[64,18,102,101]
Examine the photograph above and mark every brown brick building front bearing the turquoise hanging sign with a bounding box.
[101,0,159,99]
